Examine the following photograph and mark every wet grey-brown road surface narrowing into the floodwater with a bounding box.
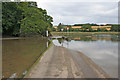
[25,44,109,78]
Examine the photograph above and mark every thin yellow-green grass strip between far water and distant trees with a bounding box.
[51,32,119,35]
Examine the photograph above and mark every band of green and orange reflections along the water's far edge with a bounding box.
[53,35,120,44]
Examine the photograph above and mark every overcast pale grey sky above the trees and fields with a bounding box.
[21,0,119,25]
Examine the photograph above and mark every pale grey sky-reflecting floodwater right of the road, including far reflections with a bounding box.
[53,35,119,78]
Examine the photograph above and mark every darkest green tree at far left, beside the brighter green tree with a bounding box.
[2,2,21,35]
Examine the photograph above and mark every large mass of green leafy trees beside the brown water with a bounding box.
[2,2,53,36]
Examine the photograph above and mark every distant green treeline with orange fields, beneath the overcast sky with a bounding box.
[52,23,120,32]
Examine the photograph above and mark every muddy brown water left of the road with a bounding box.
[2,38,47,78]
